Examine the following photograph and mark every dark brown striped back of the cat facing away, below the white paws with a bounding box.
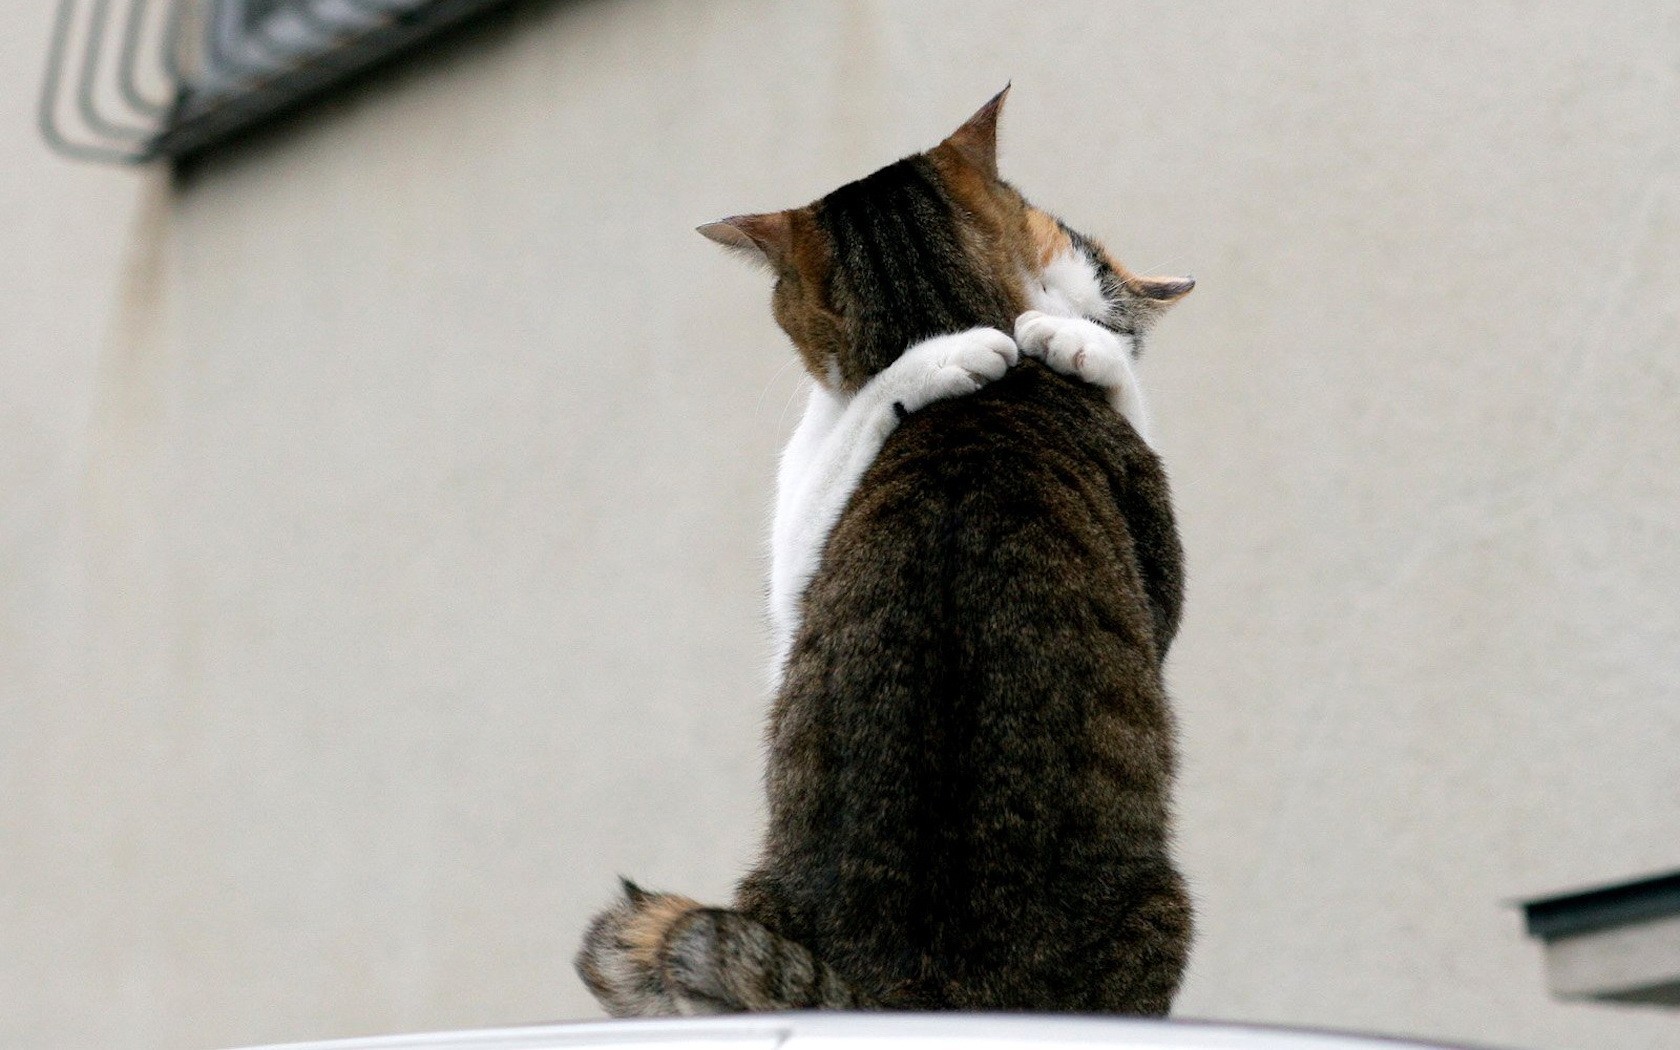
[744,363,1179,1008]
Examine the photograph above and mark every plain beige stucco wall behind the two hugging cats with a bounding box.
[0,0,1680,1050]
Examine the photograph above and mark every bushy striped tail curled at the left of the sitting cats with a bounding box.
[576,879,874,1016]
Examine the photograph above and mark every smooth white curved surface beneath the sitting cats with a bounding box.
[223,1013,1498,1050]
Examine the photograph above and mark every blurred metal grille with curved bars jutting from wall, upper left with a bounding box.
[40,0,506,163]
